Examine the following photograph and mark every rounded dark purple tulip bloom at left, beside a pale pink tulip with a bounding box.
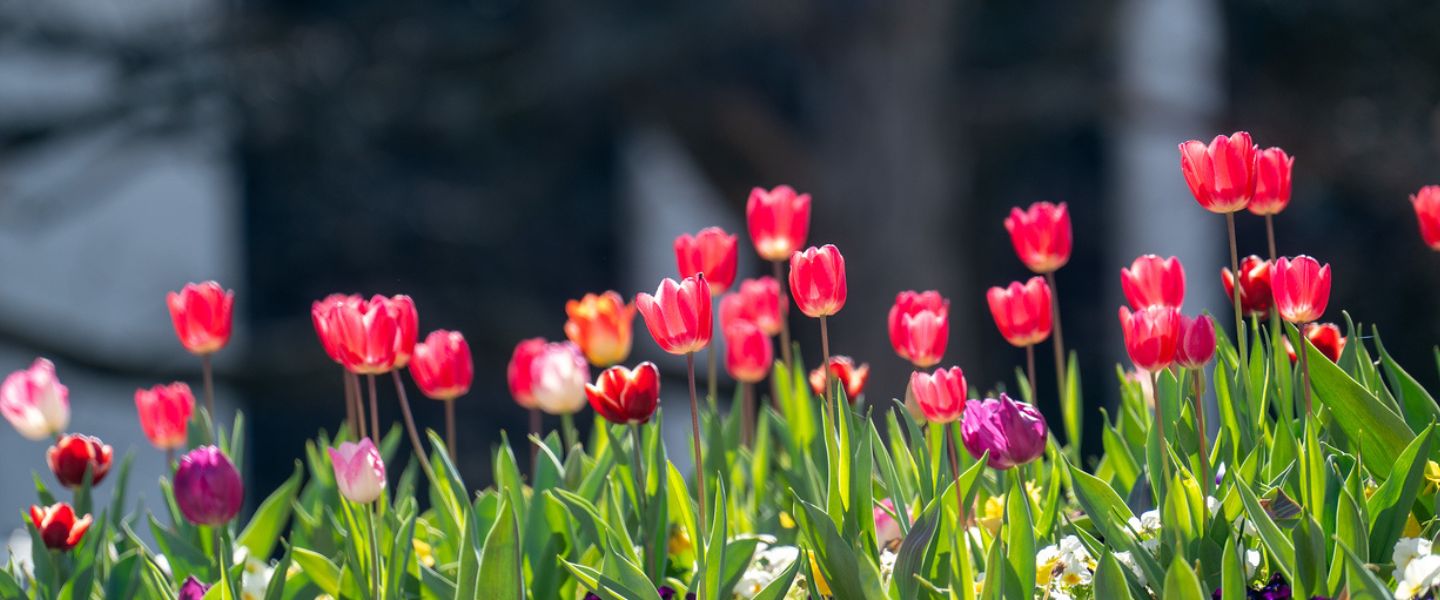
[171,446,245,527]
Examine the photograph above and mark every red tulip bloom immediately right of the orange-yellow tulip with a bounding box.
[635,273,713,354]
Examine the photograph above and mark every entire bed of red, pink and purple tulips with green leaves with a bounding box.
[0,125,1440,592]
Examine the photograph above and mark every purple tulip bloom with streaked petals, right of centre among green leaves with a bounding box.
[960,394,1048,471]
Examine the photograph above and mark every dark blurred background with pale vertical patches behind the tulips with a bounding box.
[0,0,1440,524]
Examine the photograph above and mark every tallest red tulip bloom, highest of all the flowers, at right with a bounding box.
[1179,131,1259,214]
